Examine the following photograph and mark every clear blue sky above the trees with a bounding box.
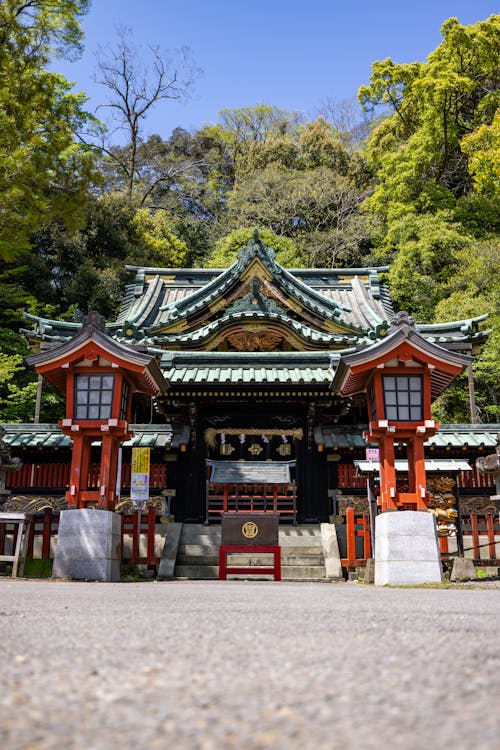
[52,0,498,138]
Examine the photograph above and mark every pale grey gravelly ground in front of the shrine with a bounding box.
[0,579,500,750]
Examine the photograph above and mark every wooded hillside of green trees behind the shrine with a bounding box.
[0,0,500,422]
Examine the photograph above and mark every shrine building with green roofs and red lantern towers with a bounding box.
[2,233,498,524]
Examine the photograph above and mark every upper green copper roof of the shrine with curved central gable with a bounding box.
[23,238,488,354]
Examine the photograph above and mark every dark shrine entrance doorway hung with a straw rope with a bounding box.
[175,400,329,523]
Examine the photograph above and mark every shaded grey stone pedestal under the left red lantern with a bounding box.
[52,509,121,581]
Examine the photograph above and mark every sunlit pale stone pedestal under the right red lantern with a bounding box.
[375,510,443,586]
